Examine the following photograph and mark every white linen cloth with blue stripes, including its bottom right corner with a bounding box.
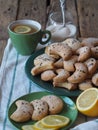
[0,39,98,130]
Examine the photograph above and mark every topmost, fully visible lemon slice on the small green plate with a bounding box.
[41,115,70,128]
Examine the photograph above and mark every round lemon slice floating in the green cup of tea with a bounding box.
[14,25,31,34]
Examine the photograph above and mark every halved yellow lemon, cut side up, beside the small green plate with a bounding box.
[76,88,98,117]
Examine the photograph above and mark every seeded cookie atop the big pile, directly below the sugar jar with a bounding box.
[63,38,81,53]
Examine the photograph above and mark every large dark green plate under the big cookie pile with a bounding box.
[25,48,81,97]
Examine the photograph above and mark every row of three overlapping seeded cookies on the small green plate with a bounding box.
[10,95,64,122]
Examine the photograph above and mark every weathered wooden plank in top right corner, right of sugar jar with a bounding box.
[77,0,98,37]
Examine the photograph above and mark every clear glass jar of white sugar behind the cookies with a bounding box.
[46,11,76,42]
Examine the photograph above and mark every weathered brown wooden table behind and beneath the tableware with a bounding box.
[0,0,98,128]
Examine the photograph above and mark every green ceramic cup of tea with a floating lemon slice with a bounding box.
[8,20,51,55]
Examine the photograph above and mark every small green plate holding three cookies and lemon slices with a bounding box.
[8,92,78,130]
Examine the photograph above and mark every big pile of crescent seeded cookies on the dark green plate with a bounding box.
[31,37,98,91]
